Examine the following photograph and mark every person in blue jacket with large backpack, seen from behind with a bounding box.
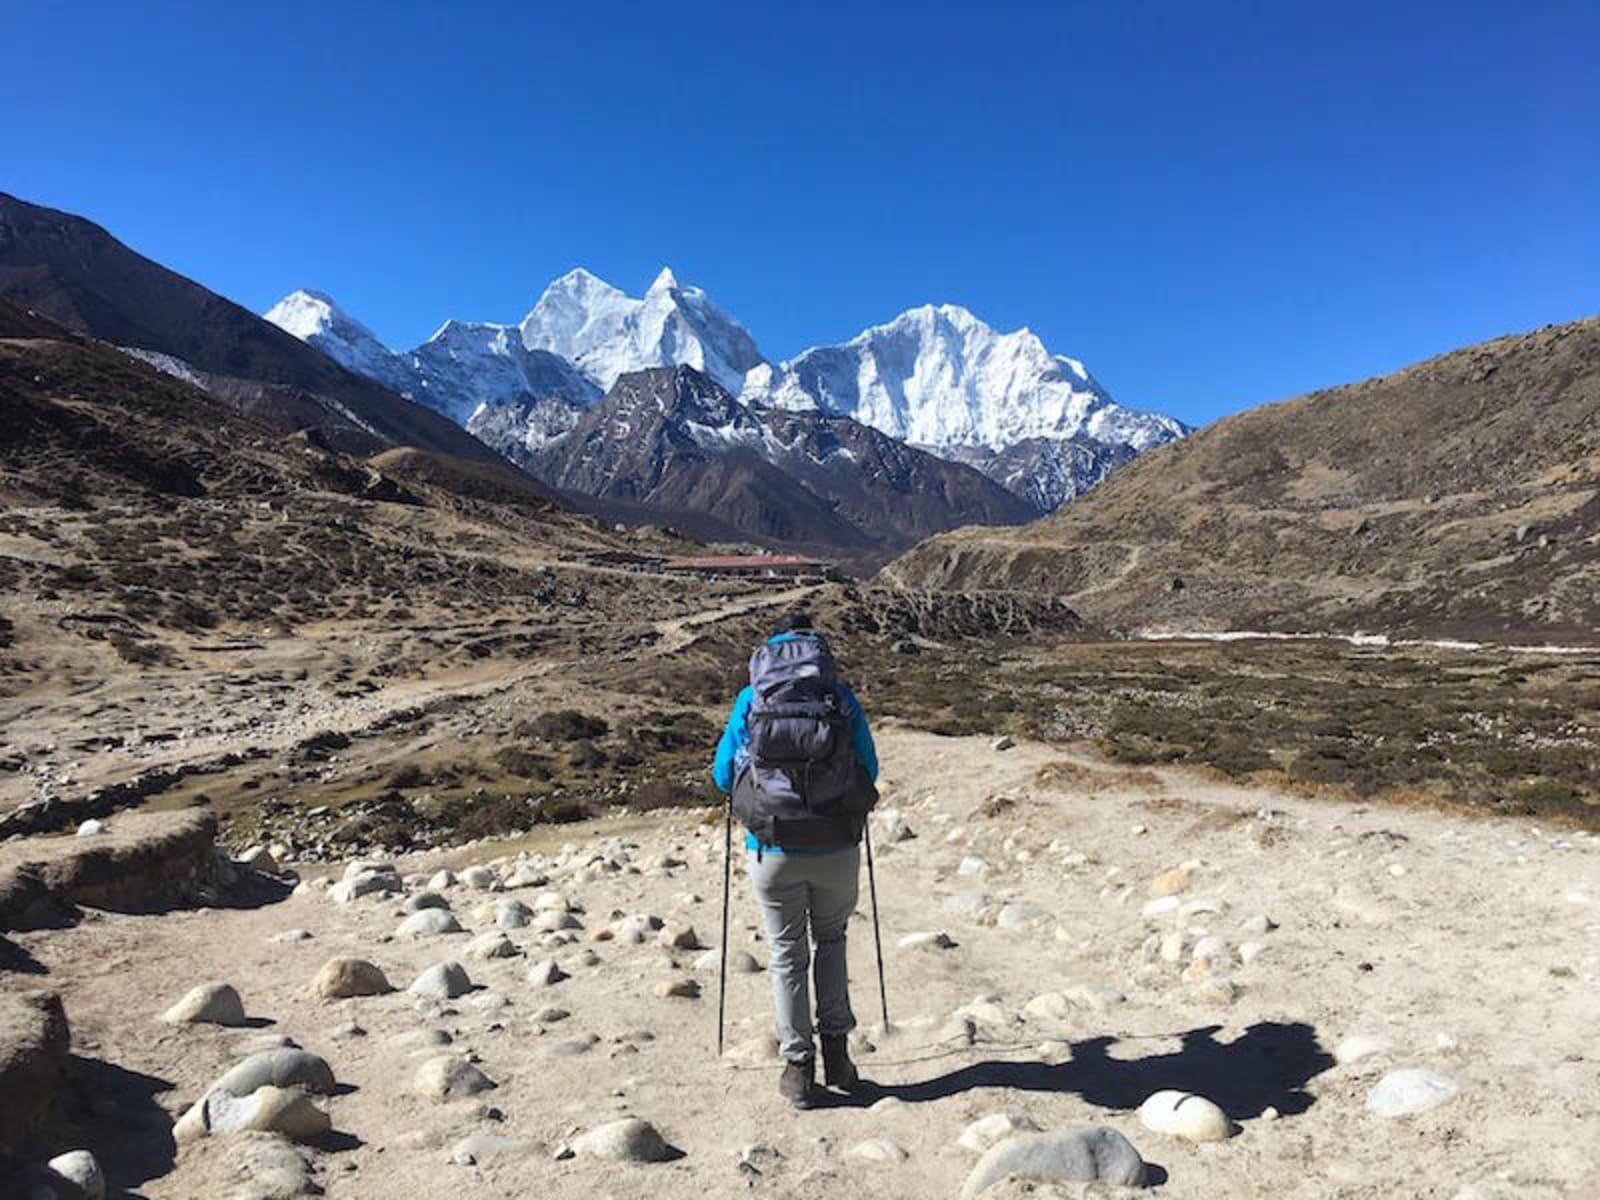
[712,613,878,1109]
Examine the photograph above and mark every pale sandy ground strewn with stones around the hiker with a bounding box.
[8,728,1600,1200]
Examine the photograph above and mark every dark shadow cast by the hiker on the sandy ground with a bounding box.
[853,1021,1333,1120]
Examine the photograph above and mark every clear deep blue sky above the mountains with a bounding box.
[0,0,1600,422]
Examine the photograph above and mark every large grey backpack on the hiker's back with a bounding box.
[733,635,878,850]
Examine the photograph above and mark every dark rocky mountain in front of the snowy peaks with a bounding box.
[475,366,1034,562]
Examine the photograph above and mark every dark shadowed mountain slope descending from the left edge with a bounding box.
[0,194,499,459]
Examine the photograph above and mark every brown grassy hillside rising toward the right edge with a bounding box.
[885,318,1600,638]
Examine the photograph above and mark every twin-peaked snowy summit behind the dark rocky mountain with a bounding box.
[520,267,766,395]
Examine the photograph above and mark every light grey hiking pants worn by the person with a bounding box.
[750,845,861,1062]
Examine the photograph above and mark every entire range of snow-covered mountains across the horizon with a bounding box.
[267,267,1187,512]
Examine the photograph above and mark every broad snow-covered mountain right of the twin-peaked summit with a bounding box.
[744,304,1184,451]
